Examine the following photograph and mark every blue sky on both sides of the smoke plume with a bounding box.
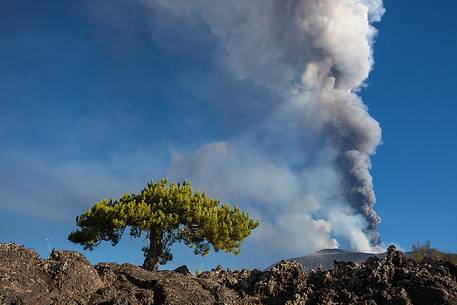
[0,0,457,269]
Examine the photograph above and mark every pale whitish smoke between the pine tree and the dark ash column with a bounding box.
[169,142,338,254]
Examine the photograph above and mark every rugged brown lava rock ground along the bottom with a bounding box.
[0,244,457,305]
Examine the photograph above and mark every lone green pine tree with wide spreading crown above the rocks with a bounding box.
[68,179,258,264]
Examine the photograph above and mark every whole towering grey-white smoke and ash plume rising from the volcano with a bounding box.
[140,0,384,252]
